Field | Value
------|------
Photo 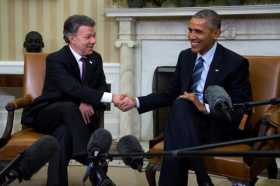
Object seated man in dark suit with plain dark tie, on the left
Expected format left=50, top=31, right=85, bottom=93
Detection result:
left=22, top=15, right=121, bottom=186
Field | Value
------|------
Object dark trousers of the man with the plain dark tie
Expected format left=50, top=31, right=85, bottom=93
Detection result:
left=33, top=102, right=95, bottom=186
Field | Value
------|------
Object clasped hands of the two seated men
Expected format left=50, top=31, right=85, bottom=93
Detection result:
left=112, top=94, right=136, bottom=112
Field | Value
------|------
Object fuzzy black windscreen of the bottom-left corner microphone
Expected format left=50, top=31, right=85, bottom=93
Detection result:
left=19, top=135, right=59, bottom=180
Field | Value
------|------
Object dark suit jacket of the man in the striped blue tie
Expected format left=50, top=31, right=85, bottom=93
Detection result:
left=138, top=44, right=251, bottom=139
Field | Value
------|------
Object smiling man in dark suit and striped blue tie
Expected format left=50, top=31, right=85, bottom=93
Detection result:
left=120, top=9, right=251, bottom=186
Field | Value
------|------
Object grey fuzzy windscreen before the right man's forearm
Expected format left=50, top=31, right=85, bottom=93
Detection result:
left=204, top=85, right=232, bottom=111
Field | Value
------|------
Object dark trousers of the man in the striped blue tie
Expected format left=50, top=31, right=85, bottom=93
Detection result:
left=159, top=99, right=211, bottom=186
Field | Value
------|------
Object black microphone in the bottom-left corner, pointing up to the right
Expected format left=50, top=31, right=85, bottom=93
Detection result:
left=0, top=135, right=59, bottom=186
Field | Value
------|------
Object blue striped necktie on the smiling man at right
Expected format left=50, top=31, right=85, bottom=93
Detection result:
left=191, top=57, right=204, bottom=93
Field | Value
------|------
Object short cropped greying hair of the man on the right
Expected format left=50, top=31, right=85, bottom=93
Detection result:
left=192, top=9, right=221, bottom=30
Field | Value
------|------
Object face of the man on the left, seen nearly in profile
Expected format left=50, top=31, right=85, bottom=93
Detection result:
left=69, top=26, right=96, bottom=56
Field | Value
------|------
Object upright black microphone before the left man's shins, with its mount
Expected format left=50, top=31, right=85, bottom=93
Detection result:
left=83, top=128, right=115, bottom=186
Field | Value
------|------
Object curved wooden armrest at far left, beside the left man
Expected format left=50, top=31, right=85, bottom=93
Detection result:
left=0, top=95, right=32, bottom=148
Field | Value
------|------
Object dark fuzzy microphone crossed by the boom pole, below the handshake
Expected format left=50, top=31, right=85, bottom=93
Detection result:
left=117, top=135, right=144, bottom=172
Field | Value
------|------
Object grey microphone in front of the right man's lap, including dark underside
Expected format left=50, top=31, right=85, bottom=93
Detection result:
left=204, top=85, right=232, bottom=122
